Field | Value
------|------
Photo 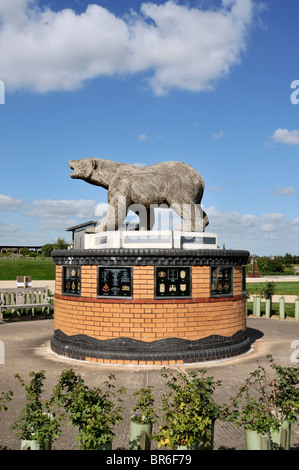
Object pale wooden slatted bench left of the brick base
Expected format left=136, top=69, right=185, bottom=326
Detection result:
left=0, top=287, right=53, bottom=319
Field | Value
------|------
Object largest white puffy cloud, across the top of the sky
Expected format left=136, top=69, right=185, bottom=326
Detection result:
left=0, top=0, right=254, bottom=95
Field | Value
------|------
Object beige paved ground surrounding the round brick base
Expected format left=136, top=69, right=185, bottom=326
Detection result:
left=0, top=317, right=299, bottom=450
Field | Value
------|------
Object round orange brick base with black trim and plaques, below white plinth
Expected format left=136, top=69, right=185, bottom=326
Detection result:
left=51, top=248, right=250, bottom=365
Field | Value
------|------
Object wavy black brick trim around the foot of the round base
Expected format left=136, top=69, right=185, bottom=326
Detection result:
left=51, top=330, right=251, bottom=363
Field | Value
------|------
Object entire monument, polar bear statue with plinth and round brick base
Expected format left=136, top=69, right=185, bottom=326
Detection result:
left=51, top=158, right=250, bottom=365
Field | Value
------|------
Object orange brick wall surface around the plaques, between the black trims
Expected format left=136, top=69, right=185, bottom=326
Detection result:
left=54, top=266, right=246, bottom=342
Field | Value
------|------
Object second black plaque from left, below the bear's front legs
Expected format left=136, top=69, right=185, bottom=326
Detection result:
left=98, top=266, right=132, bottom=297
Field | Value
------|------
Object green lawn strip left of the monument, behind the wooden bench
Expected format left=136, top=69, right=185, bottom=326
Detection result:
left=0, top=258, right=55, bottom=281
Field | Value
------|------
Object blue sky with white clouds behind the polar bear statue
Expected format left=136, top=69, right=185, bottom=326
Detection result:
left=0, top=0, right=299, bottom=256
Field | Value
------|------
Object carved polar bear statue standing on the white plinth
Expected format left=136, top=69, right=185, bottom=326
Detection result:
left=69, top=158, right=209, bottom=232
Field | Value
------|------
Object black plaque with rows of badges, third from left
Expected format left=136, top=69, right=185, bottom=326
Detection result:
left=155, top=266, right=191, bottom=298
